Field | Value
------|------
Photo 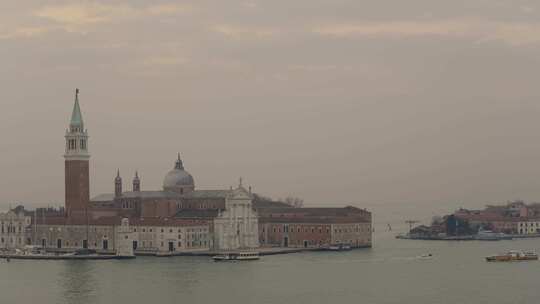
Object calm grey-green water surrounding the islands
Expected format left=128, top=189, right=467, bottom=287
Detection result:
left=0, top=203, right=540, bottom=304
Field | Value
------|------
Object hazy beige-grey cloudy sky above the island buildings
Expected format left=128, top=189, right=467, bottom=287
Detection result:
left=0, top=0, right=540, bottom=213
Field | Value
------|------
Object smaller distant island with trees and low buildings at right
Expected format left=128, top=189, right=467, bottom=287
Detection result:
left=397, top=200, right=540, bottom=240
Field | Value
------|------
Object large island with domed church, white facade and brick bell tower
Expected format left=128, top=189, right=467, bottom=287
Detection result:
left=0, top=90, right=372, bottom=255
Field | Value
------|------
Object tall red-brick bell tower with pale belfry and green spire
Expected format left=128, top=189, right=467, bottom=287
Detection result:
left=64, top=89, right=90, bottom=218
